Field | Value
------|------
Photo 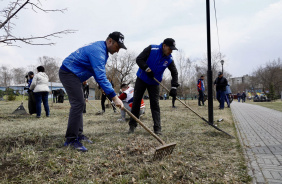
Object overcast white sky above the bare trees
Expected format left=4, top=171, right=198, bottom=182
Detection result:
left=0, top=0, right=282, bottom=77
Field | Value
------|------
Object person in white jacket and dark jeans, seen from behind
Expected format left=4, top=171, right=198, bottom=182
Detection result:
left=30, top=66, right=50, bottom=118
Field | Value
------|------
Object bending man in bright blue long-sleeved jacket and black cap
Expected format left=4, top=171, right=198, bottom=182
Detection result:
left=59, top=32, right=126, bottom=151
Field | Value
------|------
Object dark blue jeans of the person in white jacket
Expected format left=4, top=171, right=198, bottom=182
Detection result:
left=34, top=92, right=50, bottom=116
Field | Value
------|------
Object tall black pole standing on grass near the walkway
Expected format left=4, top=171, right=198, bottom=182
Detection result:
left=206, top=0, right=213, bottom=124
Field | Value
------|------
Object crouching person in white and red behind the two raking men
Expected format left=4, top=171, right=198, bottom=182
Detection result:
left=118, top=84, right=145, bottom=121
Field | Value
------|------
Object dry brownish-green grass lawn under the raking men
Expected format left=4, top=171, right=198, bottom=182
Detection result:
left=0, top=100, right=251, bottom=184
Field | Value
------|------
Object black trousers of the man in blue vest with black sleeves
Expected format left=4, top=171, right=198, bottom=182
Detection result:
left=129, top=77, right=161, bottom=131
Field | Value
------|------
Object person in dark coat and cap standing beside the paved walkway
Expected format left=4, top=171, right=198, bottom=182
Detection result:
left=214, top=72, right=228, bottom=110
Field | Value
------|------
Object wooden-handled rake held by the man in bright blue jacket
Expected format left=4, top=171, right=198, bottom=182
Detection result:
left=123, top=108, right=176, bottom=160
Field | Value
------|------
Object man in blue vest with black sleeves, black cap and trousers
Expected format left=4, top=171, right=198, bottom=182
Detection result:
left=128, top=38, right=179, bottom=135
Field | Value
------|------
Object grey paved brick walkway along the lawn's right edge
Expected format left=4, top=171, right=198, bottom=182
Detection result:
left=231, top=101, right=282, bottom=184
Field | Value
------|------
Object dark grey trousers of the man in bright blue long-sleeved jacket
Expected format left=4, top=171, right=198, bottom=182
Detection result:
left=59, top=69, right=85, bottom=141
